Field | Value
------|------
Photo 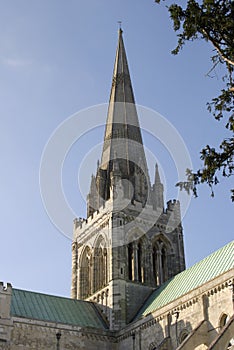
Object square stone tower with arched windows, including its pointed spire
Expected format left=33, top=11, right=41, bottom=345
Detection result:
left=71, top=29, right=185, bottom=330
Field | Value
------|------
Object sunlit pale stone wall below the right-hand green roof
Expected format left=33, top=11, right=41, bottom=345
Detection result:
left=115, top=271, right=233, bottom=350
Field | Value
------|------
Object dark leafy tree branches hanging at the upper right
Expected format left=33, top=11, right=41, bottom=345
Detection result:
left=155, top=0, right=234, bottom=201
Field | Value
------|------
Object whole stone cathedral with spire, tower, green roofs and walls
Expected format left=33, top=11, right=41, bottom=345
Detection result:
left=0, top=29, right=234, bottom=350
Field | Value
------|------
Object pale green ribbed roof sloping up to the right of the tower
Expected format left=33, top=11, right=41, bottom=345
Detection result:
left=136, top=241, right=234, bottom=319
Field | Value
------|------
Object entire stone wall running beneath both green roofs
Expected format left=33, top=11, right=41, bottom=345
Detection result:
left=0, top=270, right=234, bottom=350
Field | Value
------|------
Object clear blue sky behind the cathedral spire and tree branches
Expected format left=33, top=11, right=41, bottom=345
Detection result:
left=0, top=0, right=233, bottom=296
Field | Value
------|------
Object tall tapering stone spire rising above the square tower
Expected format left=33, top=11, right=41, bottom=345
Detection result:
left=94, top=28, right=150, bottom=203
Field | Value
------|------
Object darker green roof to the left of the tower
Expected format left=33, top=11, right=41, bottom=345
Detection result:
left=11, top=288, right=107, bottom=329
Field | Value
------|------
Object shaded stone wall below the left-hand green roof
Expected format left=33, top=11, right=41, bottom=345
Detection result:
left=0, top=318, right=116, bottom=350
